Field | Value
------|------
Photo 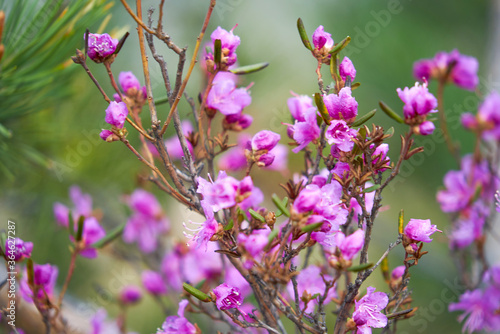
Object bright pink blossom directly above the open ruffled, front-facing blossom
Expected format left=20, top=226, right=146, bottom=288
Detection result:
left=323, top=87, right=358, bottom=122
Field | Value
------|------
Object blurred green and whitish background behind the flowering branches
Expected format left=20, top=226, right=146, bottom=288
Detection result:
left=0, top=0, right=492, bottom=333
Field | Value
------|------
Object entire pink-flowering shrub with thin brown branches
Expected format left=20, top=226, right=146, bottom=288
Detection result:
left=2, top=1, right=500, bottom=334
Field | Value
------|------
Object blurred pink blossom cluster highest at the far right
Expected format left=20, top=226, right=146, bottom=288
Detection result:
left=413, top=50, right=479, bottom=90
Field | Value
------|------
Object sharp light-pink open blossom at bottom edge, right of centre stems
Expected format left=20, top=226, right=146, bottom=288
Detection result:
left=352, top=286, right=389, bottom=334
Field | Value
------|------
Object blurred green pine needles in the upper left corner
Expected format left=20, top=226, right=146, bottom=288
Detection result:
left=0, top=0, right=110, bottom=179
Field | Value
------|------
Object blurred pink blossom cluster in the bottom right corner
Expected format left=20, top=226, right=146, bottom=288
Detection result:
left=448, top=289, right=500, bottom=334
